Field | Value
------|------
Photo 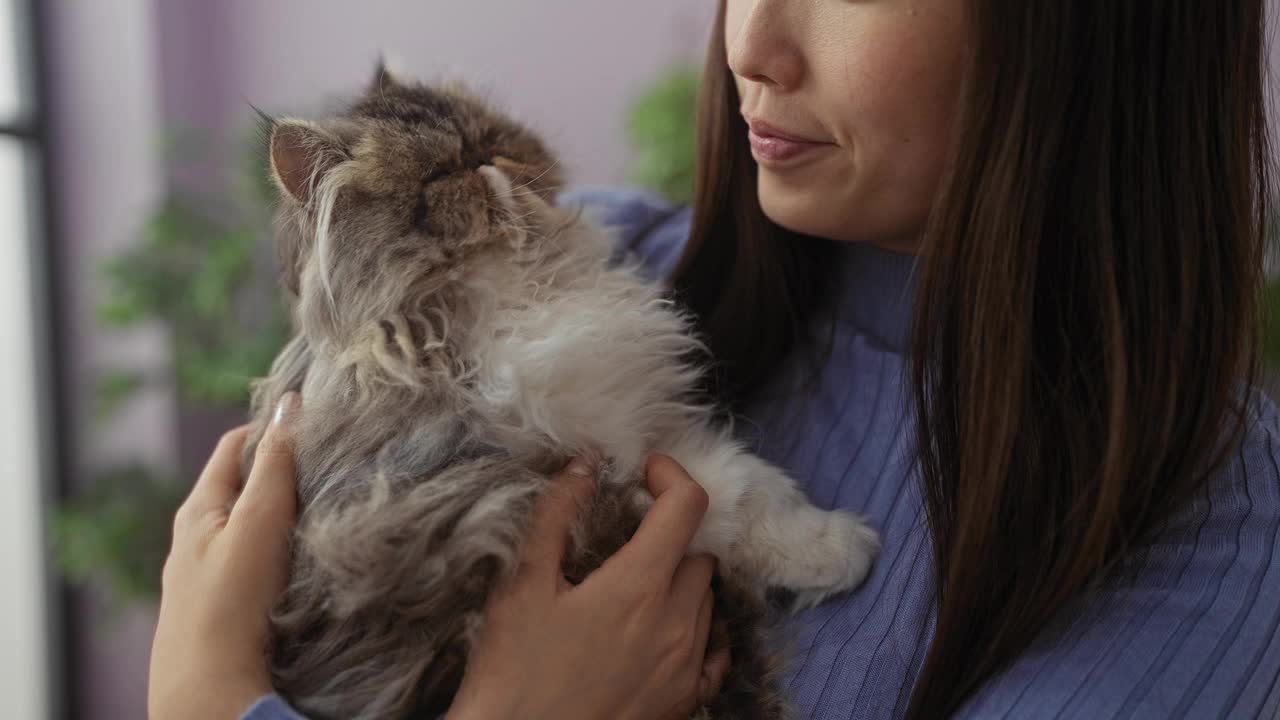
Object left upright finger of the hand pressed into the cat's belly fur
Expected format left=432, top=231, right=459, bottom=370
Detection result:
left=520, top=457, right=595, bottom=591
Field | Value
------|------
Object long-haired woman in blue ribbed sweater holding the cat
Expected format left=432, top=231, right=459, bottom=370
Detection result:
left=151, top=0, right=1280, bottom=719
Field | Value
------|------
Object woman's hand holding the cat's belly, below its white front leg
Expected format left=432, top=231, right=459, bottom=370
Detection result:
left=448, top=456, right=730, bottom=720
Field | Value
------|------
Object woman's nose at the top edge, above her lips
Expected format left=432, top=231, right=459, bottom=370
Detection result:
left=726, top=0, right=804, bottom=90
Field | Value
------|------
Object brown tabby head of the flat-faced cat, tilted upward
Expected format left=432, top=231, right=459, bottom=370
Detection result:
left=270, top=67, right=558, bottom=327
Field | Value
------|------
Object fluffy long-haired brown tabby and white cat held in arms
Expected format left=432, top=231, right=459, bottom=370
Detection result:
left=244, top=67, right=878, bottom=720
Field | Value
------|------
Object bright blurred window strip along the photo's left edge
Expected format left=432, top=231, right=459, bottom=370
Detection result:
left=0, top=0, right=63, bottom=719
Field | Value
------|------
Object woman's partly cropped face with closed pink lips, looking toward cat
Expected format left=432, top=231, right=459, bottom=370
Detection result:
left=724, top=0, right=963, bottom=252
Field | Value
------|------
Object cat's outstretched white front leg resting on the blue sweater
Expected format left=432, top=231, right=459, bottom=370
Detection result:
left=655, top=428, right=879, bottom=607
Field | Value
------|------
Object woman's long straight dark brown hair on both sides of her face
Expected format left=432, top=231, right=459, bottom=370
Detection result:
left=673, top=0, right=1271, bottom=719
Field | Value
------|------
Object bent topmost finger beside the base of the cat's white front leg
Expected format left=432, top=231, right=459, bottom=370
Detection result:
left=607, top=455, right=708, bottom=580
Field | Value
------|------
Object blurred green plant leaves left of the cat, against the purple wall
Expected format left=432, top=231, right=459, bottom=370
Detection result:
left=60, top=131, right=291, bottom=605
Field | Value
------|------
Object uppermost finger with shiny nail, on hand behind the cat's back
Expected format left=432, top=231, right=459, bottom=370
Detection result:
left=227, top=392, right=300, bottom=536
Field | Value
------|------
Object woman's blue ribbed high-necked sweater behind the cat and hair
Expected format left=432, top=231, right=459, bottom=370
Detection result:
left=244, top=191, right=1280, bottom=720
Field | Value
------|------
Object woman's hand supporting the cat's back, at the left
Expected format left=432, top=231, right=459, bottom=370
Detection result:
left=147, top=393, right=298, bottom=720
